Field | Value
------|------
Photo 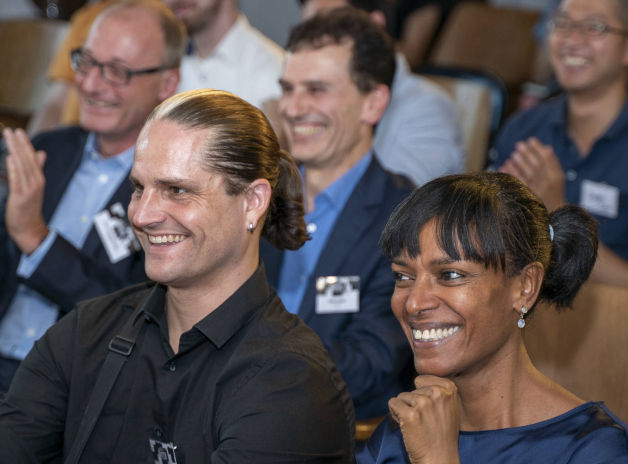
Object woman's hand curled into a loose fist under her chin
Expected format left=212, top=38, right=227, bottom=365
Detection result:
left=388, top=375, right=460, bottom=464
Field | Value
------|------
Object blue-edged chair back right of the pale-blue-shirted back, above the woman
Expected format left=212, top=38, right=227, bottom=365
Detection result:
left=416, top=65, right=507, bottom=172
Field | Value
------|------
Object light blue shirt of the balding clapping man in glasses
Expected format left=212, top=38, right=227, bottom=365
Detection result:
left=0, top=133, right=134, bottom=360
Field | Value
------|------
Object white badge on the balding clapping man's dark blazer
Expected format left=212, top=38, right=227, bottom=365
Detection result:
left=94, top=203, right=140, bottom=264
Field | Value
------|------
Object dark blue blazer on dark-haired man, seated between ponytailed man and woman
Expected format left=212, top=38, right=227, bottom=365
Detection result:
left=260, top=157, right=413, bottom=419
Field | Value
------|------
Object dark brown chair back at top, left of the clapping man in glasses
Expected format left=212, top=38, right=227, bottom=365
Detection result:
left=428, top=2, right=540, bottom=115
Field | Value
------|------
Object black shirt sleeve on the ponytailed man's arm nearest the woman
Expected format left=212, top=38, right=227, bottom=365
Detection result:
left=211, top=346, right=355, bottom=464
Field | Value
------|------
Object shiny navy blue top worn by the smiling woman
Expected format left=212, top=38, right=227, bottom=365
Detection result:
left=356, top=403, right=628, bottom=464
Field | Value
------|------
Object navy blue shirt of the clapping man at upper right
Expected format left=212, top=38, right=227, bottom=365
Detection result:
left=493, top=95, right=628, bottom=259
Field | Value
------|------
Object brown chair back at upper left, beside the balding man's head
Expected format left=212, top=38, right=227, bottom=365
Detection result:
left=0, top=19, right=68, bottom=127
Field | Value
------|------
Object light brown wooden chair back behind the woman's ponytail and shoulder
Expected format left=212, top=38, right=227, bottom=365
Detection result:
left=524, top=283, right=628, bottom=421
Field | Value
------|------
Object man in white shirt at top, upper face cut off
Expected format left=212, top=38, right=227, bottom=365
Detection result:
left=164, top=0, right=283, bottom=108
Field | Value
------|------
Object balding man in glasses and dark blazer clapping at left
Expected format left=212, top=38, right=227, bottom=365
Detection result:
left=0, top=0, right=185, bottom=391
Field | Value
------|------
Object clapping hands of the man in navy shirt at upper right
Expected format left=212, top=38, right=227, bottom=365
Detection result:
left=499, top=137, right=567, bottom=211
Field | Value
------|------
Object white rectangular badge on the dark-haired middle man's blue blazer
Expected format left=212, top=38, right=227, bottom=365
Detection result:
left=316, top=276, right=360, bottom=314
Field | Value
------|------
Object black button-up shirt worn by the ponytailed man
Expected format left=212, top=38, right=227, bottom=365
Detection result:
left=0, top=267, right=354, bottom=464
